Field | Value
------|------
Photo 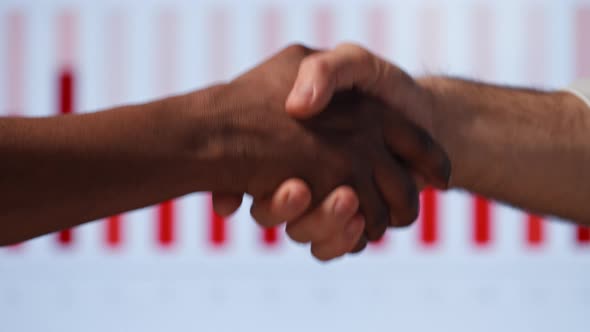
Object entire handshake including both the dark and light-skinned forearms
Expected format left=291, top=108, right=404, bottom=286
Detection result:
left=5, top=44, right=590, bottom=252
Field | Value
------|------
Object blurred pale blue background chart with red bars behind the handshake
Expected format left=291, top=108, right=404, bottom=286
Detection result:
left=0, top=0, right=590, bottom=332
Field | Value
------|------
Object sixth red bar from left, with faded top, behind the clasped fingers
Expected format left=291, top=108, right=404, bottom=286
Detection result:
left=262, top=8, right=282, bottom=247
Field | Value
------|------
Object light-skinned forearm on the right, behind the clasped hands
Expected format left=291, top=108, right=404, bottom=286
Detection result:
left=419, top=77, right=590, bottom=224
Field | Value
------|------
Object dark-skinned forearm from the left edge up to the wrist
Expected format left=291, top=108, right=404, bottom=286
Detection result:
left=0, top=83, right=245, bottom=244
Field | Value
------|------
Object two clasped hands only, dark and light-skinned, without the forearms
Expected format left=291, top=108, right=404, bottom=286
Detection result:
left=185, top=44, right=451, bottom=260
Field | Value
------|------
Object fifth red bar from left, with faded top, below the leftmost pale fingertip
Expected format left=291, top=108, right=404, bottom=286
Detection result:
left=208, top=8, right=230, bottom=248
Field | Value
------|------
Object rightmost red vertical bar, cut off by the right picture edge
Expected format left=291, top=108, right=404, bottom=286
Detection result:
left=575, top=5, right=590, bottom=245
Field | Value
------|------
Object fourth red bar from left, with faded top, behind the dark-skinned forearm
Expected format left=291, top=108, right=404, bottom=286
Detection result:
left=156, top=10, right=178, bottom=247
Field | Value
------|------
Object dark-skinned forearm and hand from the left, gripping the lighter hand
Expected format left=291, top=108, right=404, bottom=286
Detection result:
left=0, top=46, right=448, bottom=248
